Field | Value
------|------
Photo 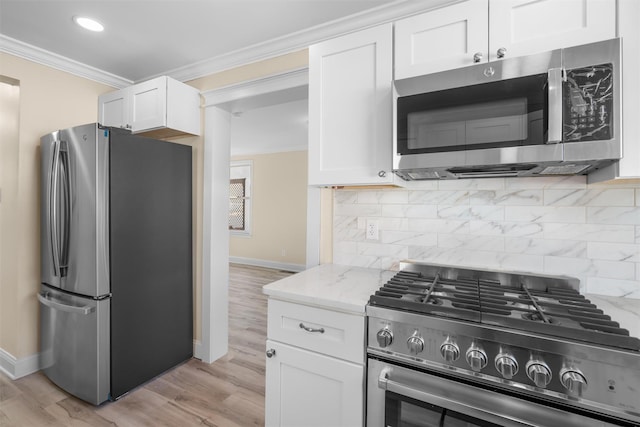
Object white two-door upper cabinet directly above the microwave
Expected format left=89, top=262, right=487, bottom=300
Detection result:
left=395, top=0, right=616, bottom=80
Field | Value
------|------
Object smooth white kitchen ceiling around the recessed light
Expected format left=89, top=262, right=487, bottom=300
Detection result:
left=0, top=0, right=406, bottom=82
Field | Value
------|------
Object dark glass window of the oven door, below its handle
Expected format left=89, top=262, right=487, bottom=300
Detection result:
left=384, top=392, right=500, bottom=427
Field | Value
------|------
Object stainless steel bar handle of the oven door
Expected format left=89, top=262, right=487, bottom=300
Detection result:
left=378, top=367, right=521, bottom=425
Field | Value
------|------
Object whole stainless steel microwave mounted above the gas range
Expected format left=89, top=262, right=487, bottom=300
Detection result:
left=393, top=39, right=622, bottom=180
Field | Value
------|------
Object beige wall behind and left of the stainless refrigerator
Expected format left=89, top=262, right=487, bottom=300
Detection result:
left=0, top=53, right=112, bottom=358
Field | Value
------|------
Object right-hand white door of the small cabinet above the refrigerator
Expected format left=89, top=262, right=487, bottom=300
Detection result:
left=131, top=77, right=167, bottom=133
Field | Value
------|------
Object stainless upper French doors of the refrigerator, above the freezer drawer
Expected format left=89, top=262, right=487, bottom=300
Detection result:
left=40, top=124, right=110, bottom=297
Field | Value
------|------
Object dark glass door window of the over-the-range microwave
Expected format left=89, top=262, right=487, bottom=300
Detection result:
left=397, top=73, right=549, bottom=154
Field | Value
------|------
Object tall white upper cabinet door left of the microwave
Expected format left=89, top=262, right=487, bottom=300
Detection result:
left=309, top=24, right=393, bottom=185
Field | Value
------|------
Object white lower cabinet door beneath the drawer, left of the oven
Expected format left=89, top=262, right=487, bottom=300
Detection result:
left=265, top=340, right=364, bottom=427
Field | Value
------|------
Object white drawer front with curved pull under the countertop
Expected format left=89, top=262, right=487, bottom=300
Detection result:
left=267, top=299, right=365, bottom=364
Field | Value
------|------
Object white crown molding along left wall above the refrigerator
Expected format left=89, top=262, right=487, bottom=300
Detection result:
left=0, top=34, right=133, bottom=88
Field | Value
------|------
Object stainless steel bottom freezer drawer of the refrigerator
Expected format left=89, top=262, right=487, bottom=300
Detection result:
left=38, top=286, right=111, bottom=405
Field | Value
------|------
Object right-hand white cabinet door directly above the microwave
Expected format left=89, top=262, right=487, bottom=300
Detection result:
left=489, top=0, right=616, bottom=61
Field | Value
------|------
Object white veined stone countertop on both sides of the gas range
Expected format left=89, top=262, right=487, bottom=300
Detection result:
left=262, top=264, right=640, bottom=337
